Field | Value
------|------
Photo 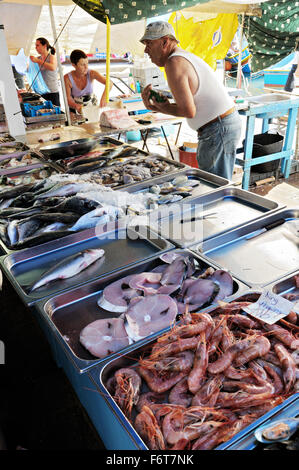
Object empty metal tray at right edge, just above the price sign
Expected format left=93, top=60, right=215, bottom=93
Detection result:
left=190, top=209, right=299, bottom=288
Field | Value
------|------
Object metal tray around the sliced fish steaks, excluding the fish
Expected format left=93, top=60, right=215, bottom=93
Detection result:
left=35, top=250, right=245, bottom=372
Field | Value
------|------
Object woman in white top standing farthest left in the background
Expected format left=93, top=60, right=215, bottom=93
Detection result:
left=30, top=38, right=60, bottom=106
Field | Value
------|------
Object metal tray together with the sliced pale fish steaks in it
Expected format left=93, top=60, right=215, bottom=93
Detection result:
left=34, top=246, right=245, bottom=375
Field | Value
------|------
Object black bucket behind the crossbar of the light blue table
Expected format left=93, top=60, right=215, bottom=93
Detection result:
left=243, top=132, right=284, bottom=173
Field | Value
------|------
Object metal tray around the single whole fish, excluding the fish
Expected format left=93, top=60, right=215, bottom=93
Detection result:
left=0, top=224, right=173, bottom=306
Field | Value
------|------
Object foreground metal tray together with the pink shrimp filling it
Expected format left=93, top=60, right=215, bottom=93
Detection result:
left=74, top=291, right=298, bottom=450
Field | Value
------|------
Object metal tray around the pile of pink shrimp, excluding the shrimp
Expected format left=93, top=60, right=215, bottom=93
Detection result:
left=87, top=290, right=299, bottom=450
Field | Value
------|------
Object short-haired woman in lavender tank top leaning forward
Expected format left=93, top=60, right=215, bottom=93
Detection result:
left=64, top=49, right=113, bottom=113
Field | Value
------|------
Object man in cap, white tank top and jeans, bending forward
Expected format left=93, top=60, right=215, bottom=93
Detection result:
left=140, top=21, right=241, bottom=179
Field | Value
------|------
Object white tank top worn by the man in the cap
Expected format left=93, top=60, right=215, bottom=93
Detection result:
left=169, top=49, right=235, bottom=130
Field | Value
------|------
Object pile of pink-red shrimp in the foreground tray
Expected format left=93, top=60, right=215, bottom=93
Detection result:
left=107, top=301, right=299, bottom=450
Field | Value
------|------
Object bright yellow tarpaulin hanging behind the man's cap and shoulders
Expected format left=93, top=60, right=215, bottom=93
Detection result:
left=168, top=11, right=238, bottom=70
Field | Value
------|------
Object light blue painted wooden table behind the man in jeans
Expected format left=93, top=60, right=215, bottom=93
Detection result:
left=236, top=94, right=299, bottom=189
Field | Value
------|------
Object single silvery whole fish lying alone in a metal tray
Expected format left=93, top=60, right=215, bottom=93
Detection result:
left=30, top=248, right=105, bottom=292
